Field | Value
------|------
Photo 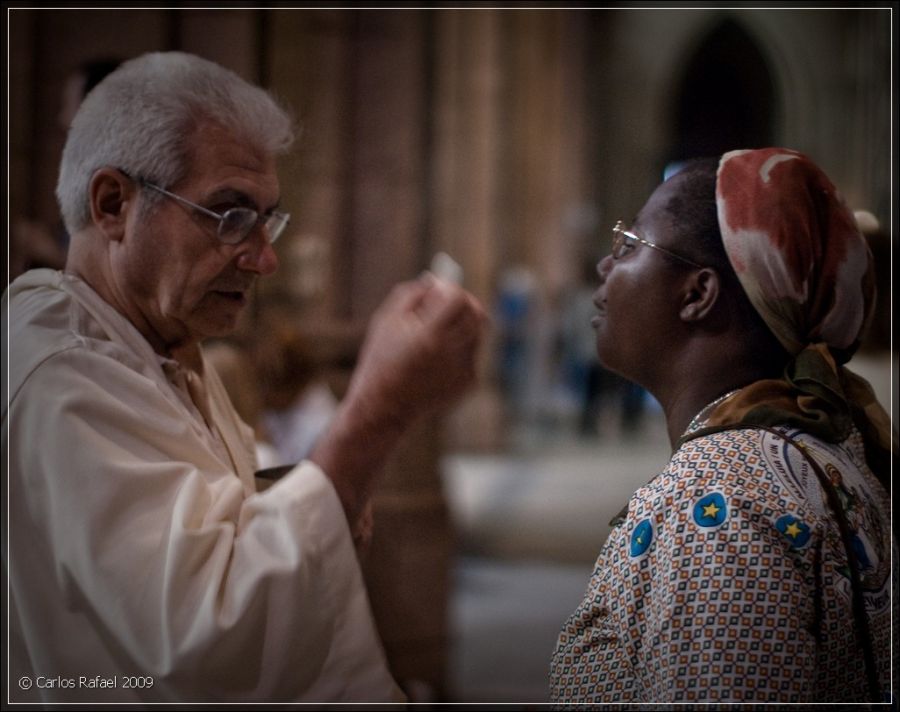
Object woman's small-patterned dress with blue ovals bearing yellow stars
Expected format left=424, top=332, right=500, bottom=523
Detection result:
left=550, top=414, right=896, bottom=704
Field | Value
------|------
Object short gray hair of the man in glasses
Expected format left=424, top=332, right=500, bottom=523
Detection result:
left=56, top=52, right=294, bottom=233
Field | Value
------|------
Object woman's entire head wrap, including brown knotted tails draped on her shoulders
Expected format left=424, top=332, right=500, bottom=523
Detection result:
left=693, top=148, right=893, bottom=482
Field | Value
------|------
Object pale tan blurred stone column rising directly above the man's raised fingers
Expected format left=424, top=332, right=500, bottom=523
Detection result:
left=430, top=10, right=505, bottom=450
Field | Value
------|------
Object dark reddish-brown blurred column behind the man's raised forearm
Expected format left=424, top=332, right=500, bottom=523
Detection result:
left=341, top=11, right=453, bottom=701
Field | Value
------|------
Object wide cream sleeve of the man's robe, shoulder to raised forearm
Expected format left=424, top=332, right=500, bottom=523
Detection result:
left=4, top=348, right=396, bottom=701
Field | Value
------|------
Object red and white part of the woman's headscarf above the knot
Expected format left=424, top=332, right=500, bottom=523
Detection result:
left=716, top=148, right=875, bottom=362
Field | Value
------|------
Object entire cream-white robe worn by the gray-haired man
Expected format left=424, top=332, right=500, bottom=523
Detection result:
left=2, top=270, right=402, bottom=702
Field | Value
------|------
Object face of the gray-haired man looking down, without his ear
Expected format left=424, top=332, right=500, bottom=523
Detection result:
left=110, top=123, right=279, bottom=350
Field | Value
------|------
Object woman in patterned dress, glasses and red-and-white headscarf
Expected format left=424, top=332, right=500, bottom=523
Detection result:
left=551, top=148, right=896, bottom=703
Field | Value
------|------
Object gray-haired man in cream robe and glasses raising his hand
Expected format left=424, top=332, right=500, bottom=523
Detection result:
left=3, top=53, right=483, bottom=702
